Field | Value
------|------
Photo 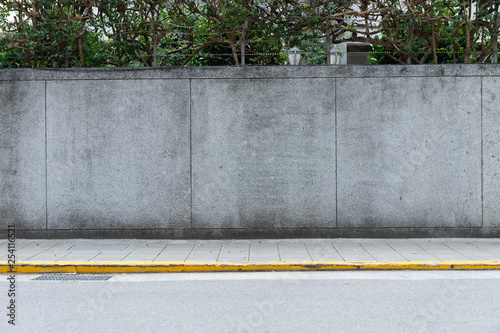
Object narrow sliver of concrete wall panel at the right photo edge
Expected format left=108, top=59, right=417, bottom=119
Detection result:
left=482, top=77, right=500, bottom=227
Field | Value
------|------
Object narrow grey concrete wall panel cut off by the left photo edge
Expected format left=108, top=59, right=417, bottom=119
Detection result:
left=0, top=81, right=46, bottom=229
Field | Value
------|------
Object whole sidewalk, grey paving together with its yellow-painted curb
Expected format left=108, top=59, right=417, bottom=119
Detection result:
left=0, top=238, right=500, bottom=274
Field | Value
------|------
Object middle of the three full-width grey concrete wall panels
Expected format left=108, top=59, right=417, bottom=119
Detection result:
left=191, top=78, right=335, bottom=229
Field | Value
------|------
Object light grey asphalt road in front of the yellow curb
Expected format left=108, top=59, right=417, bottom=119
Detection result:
left=0, top=271, right=500, bottom=332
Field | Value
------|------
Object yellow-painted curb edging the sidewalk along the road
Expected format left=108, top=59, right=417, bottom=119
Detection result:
left=0, top=260, right=500, bottom=274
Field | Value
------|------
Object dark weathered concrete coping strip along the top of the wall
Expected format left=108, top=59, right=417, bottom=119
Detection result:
left=0, top=64, right=500, bottom=81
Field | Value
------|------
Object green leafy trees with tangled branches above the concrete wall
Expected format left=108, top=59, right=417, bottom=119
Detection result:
left=0, top=0, right=500, bottom=67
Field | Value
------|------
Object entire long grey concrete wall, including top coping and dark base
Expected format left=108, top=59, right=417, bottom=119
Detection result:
left=0, top=65, right=500, bottom=238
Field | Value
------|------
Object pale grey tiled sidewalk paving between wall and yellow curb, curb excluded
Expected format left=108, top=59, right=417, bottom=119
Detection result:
left=5, top=239, right=500, bottom=262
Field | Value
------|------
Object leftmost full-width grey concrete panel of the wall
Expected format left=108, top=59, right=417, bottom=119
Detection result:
left=47, top=80, right=191, bottom=229
